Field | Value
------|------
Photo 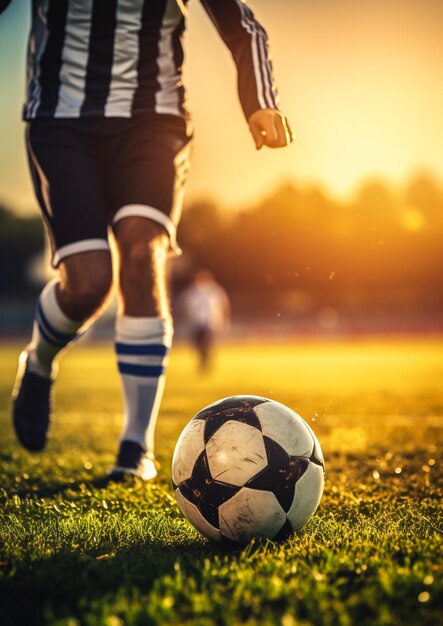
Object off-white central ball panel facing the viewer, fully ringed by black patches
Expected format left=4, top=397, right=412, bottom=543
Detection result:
left=206, top=420, right=268, bottom=487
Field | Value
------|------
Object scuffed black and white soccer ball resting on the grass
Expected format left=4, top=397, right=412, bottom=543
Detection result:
left=172, top=396, right=324, bottom=543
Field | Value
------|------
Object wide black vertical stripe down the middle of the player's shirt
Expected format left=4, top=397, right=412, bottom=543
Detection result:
left=82, top=0, right=117, bottom=115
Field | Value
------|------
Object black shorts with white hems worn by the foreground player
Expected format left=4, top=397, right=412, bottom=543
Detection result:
left=26, top=114, right=192, bottom=267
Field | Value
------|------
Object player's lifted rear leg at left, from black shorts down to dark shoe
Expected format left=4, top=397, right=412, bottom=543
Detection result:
left=13, top=120, right=112, bottom=451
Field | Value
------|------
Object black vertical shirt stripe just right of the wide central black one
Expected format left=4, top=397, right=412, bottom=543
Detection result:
left=132, top=0, right=167, bottom=111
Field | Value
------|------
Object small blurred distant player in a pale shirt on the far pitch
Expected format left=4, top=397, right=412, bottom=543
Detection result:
left=179, top=270, right=230, bottom=370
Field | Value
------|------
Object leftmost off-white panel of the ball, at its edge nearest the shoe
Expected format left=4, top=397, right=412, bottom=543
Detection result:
left=172, top=420, right=206, bottom=485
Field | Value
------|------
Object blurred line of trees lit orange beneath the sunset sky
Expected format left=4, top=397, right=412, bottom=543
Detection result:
left=0, top=174, right=443, bottom=312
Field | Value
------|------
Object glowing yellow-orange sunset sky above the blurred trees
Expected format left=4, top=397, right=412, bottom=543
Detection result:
left=0, top=0, right=443, bottom=211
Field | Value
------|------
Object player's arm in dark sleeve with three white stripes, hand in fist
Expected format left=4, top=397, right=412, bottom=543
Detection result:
left=201, top=0, right=292, bottom=150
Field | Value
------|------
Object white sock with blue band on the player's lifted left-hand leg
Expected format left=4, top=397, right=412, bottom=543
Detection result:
left=25, top=280, right=88, bottom=378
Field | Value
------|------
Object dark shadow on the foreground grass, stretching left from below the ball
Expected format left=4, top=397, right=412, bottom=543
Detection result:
left=0, top=542, right=241, bottom=626
